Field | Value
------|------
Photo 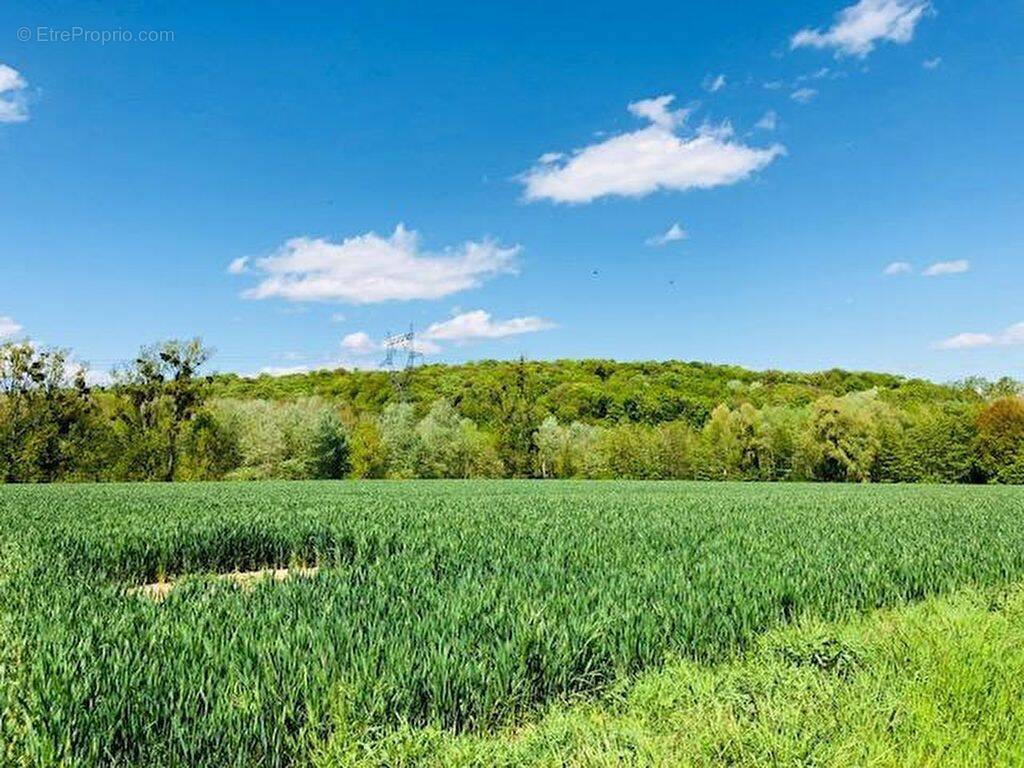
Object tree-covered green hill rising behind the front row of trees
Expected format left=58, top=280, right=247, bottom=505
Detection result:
left=214, top=359, right=974, bottom=423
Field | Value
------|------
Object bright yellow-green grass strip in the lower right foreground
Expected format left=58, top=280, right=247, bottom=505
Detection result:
left=317, top=588, right=1024, bottom=768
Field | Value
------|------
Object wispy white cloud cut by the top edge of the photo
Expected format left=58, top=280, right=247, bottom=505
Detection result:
left=790, top=0, right=932, bottom=58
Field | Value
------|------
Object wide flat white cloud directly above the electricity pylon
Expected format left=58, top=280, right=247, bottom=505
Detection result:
left=235, top=224, right=519, bottom=304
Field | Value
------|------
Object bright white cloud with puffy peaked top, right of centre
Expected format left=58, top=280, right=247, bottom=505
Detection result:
left=521, top=96, right=785, bottom=203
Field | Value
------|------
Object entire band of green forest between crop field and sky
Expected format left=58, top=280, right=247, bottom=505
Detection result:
left=0, top=339, right=1024, bottom=483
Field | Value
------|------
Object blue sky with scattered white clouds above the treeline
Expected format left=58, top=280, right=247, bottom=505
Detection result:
left=0, top=0, right=1024, bottom=380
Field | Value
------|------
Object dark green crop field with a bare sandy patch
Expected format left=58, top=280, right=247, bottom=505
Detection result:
left=0, top=481, right=1024, bottom=766
